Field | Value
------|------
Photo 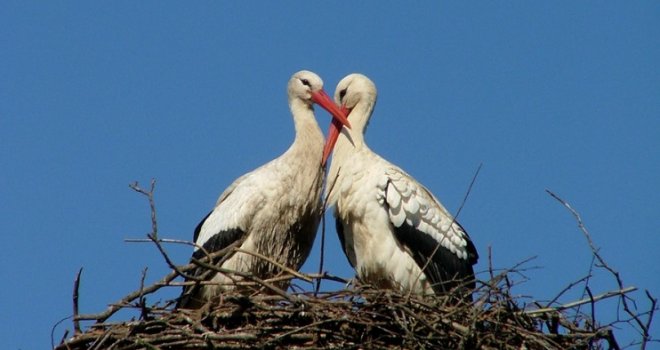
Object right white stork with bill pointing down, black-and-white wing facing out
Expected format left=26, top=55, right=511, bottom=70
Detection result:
left=323, top=74, right=478, bottom=299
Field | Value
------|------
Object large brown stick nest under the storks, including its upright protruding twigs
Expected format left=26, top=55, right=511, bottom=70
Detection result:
left=54, top=182, right=657, bottom=350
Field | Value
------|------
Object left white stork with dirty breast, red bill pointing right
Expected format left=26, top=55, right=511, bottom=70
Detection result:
left=177, top=71, right=348, bottom=309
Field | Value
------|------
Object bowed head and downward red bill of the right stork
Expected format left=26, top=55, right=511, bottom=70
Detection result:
left=323, top=73, right=378, bottom=163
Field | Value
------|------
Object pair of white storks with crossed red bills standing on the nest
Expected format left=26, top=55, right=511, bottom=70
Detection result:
left=178, top=71, right=478, bottom=308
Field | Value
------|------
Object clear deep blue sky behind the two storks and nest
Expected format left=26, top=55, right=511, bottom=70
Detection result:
left=0, top=1, right=660, bottom=349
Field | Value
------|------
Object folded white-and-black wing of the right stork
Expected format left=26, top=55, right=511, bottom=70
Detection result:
left=378, top=167, right=478, bottom=293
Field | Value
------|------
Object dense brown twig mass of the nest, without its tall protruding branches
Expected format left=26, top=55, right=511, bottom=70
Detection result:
left=57, top=268, right=636, bottom=350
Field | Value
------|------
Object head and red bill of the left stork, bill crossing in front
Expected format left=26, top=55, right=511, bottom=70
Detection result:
left=288, top=70, right=351, bottom=165
